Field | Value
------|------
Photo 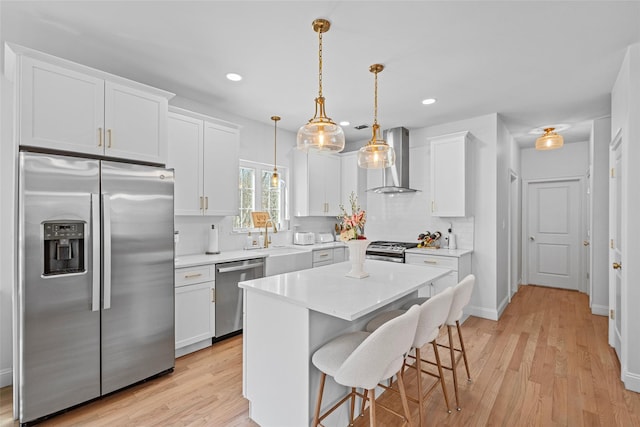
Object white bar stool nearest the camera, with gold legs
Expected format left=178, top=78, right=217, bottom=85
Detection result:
left=311, top=306, right=420, bottom=427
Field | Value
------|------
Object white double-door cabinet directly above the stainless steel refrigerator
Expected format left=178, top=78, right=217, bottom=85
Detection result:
left=8, top=45, right=173, bottom=164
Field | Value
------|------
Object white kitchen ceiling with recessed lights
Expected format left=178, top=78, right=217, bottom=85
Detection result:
left=0, top=0, right=640, bottom=147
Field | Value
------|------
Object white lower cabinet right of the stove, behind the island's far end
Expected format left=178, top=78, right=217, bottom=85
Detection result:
left=405, top=252, right=471, bottom=297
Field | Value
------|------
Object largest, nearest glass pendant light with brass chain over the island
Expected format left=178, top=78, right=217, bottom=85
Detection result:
left=297, top=19, right=344, bottom=153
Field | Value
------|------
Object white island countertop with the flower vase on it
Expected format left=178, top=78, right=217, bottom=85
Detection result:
left=238, top=260, right=451, bottom=321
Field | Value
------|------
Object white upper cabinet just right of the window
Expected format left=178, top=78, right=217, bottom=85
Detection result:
left=293, top=150, right=341, bottom=216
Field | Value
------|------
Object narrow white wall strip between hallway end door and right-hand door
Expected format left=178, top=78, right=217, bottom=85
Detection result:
left=589, top=117, right=611, bottom=316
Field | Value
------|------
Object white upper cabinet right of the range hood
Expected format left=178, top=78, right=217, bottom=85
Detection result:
left=430, top=131, right=472, bottom=217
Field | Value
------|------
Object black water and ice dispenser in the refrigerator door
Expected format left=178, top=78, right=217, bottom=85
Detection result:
left=42, top=221, right=85, bottom=276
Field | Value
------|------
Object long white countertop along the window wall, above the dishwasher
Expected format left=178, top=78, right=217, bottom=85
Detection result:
left=175, top=242, right=347, bottom=268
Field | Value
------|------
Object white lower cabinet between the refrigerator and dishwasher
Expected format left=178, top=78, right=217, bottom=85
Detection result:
left=175, top=265, right=216, bottom=357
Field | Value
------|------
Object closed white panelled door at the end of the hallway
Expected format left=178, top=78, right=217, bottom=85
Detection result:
left=527, top=179, right=582, bottom=290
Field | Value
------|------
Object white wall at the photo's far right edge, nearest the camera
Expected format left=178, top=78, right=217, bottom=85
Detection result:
left=611, top=44, right=640, bottom=392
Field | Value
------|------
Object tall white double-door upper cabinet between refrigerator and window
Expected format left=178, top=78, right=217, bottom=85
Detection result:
left=167, top=107, right=239, bottom=216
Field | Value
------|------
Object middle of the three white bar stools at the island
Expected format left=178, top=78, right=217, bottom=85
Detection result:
left=366, top=288, right=453, bottom=425
